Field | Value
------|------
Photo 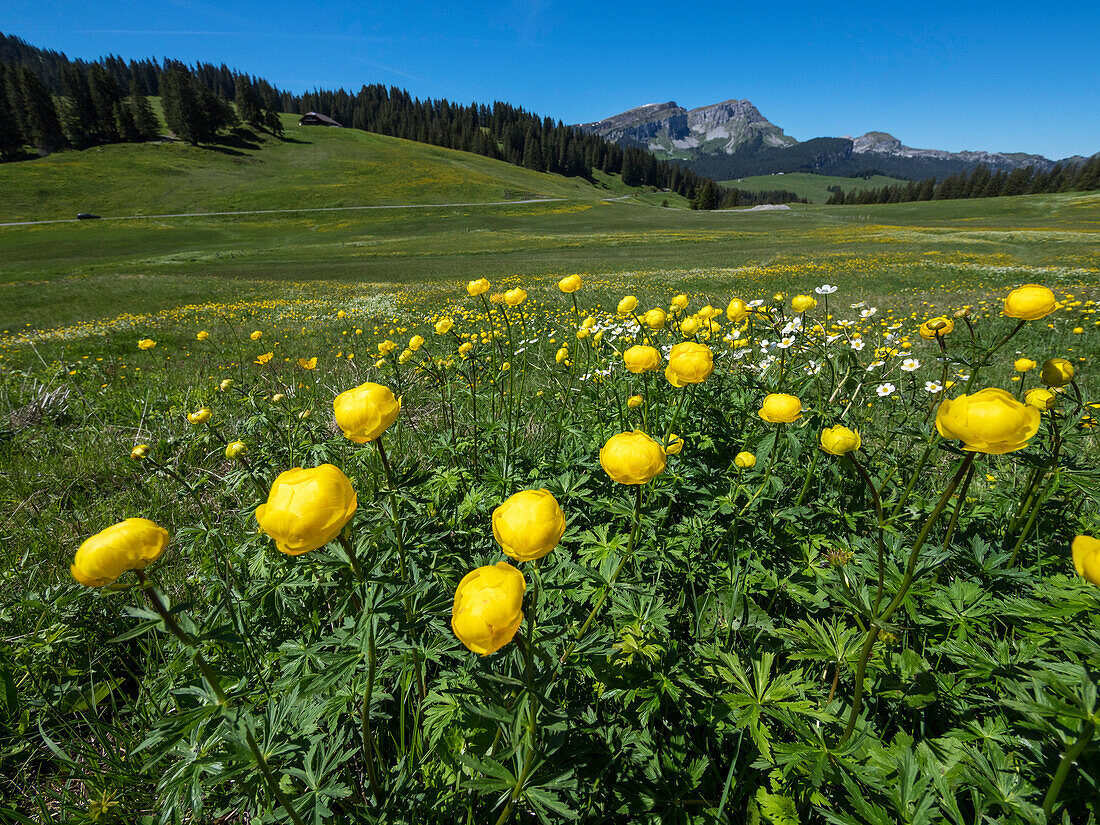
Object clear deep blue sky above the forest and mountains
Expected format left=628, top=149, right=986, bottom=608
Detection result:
left=0, top=0, right=1100, bottom=157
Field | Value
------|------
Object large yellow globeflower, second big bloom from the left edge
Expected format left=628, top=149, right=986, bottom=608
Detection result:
left=256, top=464, right=359, bottom=556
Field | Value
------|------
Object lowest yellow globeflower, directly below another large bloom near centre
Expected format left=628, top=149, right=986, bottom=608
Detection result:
left=451, top=561, right=527, bottom=656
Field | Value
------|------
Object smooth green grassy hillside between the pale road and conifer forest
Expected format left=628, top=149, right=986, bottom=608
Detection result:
left=0, top=114, right=682, bottom=222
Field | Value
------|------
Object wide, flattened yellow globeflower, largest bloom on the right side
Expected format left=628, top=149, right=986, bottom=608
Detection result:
left=936, top=388, right=1040, bottom=455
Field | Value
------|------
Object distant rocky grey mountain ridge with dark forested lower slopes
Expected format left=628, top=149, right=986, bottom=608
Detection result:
left=576, top=99, right=1086, bottom=180
